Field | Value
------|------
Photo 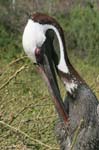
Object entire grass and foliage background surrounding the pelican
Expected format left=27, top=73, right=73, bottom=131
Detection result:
left=0, top=0, right=99, bottom=150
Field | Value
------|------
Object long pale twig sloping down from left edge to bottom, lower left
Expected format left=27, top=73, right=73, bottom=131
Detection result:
left=0, top=121, right=59, bottom=150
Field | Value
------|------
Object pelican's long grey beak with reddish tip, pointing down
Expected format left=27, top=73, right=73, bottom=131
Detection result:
left=36, top=54, right=68, bottom=123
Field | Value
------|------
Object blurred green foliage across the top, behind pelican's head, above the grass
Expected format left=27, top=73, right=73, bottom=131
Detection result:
left=0, top=0, right=99, bottom=65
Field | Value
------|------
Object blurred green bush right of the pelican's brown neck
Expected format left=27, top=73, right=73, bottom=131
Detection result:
left=65, top=5, right=99, bottom=65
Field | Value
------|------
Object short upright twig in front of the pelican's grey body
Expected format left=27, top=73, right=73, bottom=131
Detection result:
left=70, top=119, right=84, bottom=150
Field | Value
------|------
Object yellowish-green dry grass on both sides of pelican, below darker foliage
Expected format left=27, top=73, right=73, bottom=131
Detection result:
left=0, top=54, right=99, bottom=150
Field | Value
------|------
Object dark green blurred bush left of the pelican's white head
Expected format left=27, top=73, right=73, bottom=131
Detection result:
left=0, top=25, right=22, bottom=63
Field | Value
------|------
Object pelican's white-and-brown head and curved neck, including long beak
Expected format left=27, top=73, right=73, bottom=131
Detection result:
left=22, top=13, right=82, bottom=122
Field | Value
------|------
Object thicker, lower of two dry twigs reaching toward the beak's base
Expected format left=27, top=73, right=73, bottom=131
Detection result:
left=0, top=65, right=27, bottom=90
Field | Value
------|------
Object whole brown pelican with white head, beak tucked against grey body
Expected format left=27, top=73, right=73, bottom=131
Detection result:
left=22, top=13, right=99, bottom=150
